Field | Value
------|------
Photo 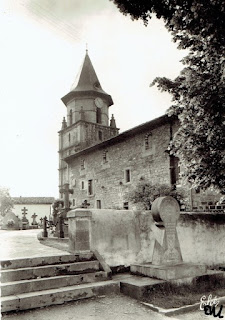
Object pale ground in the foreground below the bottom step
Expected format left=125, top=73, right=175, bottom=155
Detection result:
left=2, top=295, right=181, bottom=320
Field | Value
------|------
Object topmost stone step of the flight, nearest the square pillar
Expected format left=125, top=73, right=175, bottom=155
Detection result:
left=1, top=252, right=95, bottom=270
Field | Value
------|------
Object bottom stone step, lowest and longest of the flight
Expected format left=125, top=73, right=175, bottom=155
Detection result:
left=1, top=280, right=120, bottom=312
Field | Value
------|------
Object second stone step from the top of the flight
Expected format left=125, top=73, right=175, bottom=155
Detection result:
left=1, top=260, right=99, bottom=283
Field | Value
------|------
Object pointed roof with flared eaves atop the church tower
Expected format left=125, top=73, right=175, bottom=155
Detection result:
left=62, top=50, right=113, bottom=106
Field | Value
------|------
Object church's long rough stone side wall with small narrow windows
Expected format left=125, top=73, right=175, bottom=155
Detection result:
left=69, top=124, right=170, bottom=209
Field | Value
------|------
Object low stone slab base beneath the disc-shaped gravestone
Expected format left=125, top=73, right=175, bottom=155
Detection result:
left=130, top=263, right=207, bottom=280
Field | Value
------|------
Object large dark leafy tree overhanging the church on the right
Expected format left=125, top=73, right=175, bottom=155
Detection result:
left=113, top=0, right=225, bottom=194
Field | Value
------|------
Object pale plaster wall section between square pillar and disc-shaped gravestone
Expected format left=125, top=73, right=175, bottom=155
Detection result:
left=91, top=209, right=154, bottom=266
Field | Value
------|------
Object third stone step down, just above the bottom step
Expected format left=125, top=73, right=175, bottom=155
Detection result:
left=0, top=271, right=108, bottom=297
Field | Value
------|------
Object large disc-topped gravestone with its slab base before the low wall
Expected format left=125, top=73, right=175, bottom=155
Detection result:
left=130, top=196, right=207, bottom=280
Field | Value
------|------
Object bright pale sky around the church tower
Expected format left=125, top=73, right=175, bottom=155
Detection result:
left=0, top=0, right=186, bottom=197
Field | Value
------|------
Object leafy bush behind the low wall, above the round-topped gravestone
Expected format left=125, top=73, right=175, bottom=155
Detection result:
left=128, top=181, right=185, bottom=210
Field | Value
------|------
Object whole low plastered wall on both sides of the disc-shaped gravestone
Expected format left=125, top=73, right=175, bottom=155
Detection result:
left=69, top=209, right=225, bottom=267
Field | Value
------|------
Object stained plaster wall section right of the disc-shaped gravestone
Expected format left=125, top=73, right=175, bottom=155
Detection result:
left=177, top=212, right=225, bottom=266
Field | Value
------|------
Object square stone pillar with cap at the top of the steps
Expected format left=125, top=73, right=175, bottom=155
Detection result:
left=67, top=209, right=92, bottom=253
